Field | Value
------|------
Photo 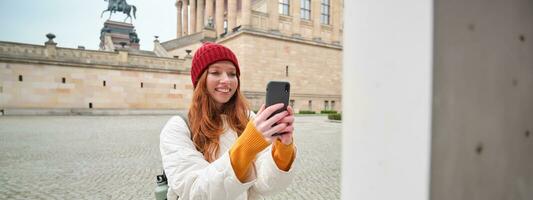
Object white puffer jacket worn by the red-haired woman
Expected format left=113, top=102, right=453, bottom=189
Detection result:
left=160, top=113, right=298, bottom=200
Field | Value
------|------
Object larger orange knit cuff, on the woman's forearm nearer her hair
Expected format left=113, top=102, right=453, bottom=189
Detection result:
left=230, top=121, right=269, bottom=182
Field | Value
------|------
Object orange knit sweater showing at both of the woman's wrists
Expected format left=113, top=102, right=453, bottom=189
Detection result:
left=230, top=121, right=294, bottom=182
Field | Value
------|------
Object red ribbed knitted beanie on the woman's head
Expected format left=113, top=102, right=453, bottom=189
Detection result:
left=191, top=42, right=240, bottom=88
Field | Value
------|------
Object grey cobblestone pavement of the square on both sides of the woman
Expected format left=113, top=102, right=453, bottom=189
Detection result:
left=0, top=116, right=341, bottom=199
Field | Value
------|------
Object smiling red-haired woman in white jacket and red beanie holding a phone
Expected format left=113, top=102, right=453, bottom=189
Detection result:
left=160, top=43, right=296, bottom=200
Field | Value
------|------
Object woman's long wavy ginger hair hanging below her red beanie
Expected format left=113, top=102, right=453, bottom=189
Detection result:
left=188, top=70, right=249, bottom=162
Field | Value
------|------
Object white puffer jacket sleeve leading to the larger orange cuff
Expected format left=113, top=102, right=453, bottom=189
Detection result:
left=160, top=116, right=255, bottom=200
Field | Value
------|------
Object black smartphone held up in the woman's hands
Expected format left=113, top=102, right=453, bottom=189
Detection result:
left=265, top=81, right=291, bottom=136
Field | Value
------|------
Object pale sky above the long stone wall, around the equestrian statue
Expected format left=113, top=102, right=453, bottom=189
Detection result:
left=0, top=0, right=176, bottom=50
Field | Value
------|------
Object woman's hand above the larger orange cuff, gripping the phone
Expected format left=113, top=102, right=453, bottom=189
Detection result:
left=254, top=103, right=292, bottom=143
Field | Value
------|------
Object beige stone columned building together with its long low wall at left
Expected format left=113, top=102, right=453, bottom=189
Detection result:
left=0, top=0, right=343, bottom=115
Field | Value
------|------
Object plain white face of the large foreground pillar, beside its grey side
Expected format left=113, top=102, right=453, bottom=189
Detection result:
left=341, top=0, right=433, bottom=200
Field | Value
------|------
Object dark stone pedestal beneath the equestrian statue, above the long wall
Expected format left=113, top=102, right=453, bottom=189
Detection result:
left=100, top=20, right=140, bottom=50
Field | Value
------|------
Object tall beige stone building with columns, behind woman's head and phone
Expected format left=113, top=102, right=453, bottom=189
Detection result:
left=162, top=0, right=343, bottom=112
